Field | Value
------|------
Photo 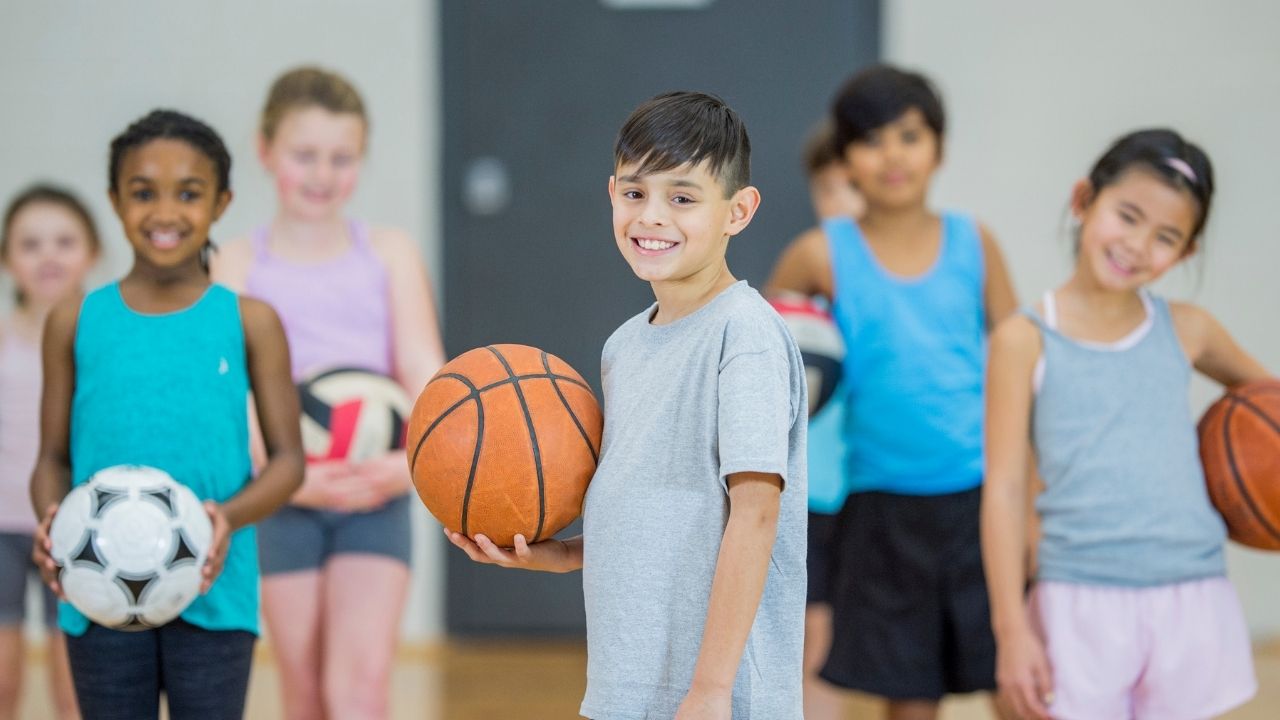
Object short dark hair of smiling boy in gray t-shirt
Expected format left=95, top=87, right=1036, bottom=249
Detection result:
left=613, top=92, right=751, bottom=197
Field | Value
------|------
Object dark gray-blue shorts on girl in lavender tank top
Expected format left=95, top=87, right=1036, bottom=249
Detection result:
left=257, top=495, right=412, bottom=575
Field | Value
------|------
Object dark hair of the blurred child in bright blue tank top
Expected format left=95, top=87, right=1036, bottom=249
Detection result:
left=831, top=65, right=947, bottom=152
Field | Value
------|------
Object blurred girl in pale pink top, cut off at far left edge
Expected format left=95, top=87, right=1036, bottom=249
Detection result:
left=0, top=184, right=100, bottom=717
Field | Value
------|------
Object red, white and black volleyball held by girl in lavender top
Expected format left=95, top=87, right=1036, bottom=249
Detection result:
left=298, top=368, right=410, bottom=462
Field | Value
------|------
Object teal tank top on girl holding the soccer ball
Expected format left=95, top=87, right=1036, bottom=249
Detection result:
left=59, top=283, right=257, bottom=635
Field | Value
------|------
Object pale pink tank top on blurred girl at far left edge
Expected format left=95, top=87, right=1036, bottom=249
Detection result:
left=0, top=334, right=42, bottom=533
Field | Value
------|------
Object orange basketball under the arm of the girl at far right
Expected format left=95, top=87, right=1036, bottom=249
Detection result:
left=1199, top=379, right=1280, bottom=550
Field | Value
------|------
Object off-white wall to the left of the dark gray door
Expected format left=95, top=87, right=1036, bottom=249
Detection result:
left=0, top=0, right=443, bottom=638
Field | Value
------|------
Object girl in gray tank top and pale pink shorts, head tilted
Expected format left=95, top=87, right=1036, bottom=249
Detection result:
left=982, top=129, right=1267, bottom=719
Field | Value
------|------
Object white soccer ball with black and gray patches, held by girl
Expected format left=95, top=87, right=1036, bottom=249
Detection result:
left=49, top=465, right=214, bottom=630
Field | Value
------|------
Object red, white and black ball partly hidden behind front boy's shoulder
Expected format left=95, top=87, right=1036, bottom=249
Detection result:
left=769, top=295, right=845, bottom=418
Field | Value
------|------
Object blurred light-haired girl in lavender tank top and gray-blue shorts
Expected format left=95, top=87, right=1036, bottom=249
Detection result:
left=212, top=67, right=444, bottom=717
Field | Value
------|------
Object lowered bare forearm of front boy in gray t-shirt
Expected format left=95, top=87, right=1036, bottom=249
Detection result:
left=692, top=503, right=778, bottom=691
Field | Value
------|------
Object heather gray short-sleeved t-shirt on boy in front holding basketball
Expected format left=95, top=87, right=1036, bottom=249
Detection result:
left=581, top=282, right=808, bottom=720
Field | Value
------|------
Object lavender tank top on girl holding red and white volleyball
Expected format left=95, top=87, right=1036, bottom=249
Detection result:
left=246, top=220, right=392, bottom=380
